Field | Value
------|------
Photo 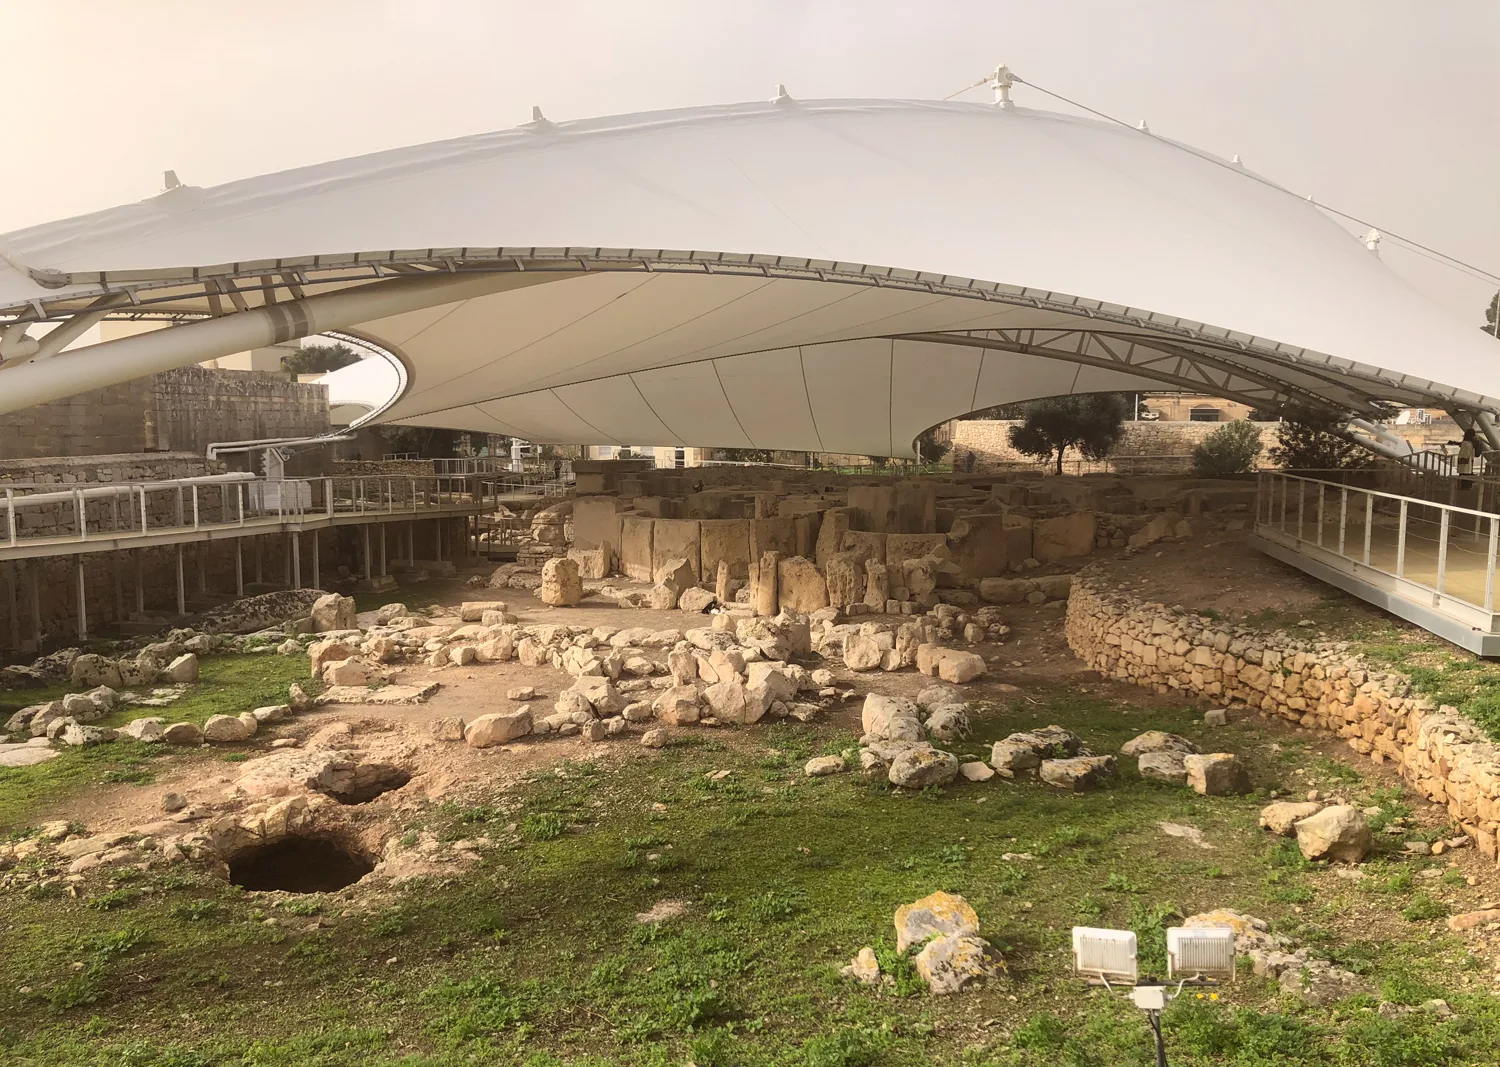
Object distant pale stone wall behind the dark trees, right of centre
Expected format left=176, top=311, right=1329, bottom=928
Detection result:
left=953, top=419, right=1281, bottom=474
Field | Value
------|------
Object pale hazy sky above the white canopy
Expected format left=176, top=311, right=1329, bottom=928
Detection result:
left=0, top=0, right=1500, bottom=326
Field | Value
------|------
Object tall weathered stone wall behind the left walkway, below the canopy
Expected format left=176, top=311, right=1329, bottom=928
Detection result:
left=0, top=366, right=329, bottom=459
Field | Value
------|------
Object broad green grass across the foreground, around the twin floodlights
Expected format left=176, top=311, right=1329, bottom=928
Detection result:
left=0, top=693, right=1500, bottom=1067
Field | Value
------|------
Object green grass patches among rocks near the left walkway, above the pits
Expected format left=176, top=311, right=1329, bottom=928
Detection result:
left=0, top=654, right=317, bottom=836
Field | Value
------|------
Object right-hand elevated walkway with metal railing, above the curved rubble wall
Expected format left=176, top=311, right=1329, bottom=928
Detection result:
left=1251, top=471, right=1500, bottom=656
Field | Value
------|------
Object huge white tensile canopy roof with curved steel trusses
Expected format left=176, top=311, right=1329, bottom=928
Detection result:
left=0, top=98, right=1500, bottom=456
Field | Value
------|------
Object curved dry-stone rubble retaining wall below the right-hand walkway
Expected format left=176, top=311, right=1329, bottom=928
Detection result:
left=1065, top=569, right=1500, bottom=858
